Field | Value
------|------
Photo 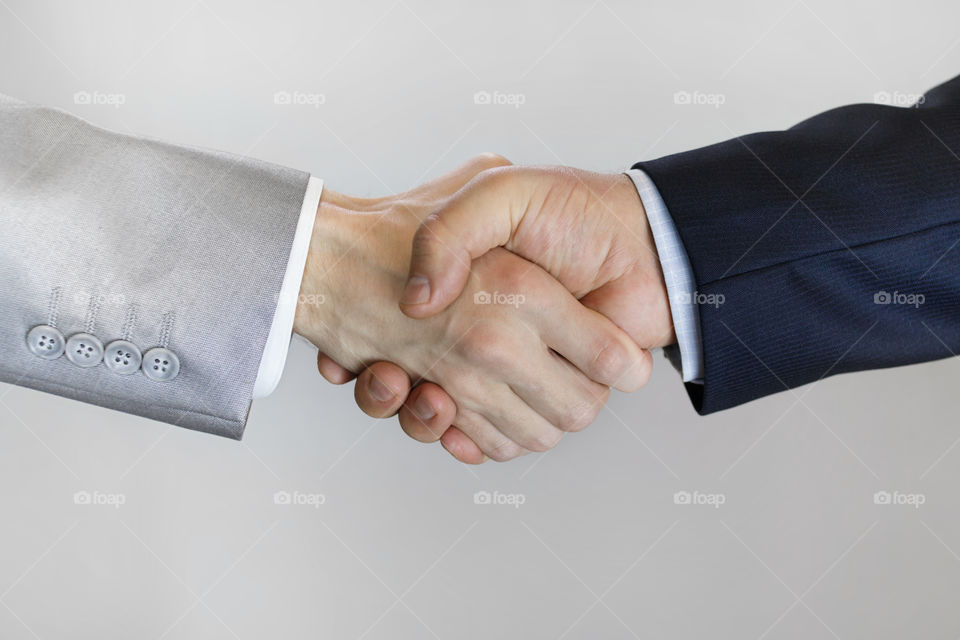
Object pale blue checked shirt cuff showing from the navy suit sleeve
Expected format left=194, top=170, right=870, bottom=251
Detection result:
left=627, top=169, right=703, bottom=383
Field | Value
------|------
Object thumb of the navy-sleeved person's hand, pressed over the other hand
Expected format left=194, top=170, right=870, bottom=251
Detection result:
left=400, top=167, right=526, bottom=318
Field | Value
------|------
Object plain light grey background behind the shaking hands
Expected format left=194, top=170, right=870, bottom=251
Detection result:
left=0, top=0, right=960, bottom=640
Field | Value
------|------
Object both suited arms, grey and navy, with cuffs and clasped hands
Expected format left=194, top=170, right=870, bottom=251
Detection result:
left=0, top=78, right=960, bottom=450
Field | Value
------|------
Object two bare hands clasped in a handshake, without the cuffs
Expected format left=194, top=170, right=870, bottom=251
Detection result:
left=294, top=154, right=676, bottom=464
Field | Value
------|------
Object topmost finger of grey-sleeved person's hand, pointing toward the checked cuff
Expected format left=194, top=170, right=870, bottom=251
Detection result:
left=532, top=282, right=653, bottom=392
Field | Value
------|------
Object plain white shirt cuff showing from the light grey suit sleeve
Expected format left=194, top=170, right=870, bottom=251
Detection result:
left=253, top=176, right=323, bottom=399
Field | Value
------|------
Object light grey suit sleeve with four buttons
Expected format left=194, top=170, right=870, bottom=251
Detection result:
left=0, top=96, right=309, bottom=439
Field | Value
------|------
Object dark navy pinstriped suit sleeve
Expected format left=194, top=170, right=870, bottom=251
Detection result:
left=635, top=77, right=960, bottom=414
